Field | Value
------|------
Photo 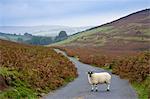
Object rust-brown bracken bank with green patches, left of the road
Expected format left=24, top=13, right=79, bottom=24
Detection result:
left=0, top=40, right=77, bottom=99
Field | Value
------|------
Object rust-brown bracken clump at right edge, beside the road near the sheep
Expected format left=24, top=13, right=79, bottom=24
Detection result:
left=113, top=52, right=150, bottom=82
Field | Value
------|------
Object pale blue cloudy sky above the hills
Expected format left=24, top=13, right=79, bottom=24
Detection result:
left=0, top=0, right=150, bottom=26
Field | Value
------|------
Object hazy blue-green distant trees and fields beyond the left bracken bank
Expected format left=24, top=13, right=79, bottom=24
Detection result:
left=0, top=31, right=68, bottom=45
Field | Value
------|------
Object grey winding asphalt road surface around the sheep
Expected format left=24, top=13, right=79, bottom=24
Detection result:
left=44, top=50, right=137, bottom=99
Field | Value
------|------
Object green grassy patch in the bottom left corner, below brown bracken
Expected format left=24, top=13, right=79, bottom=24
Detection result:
left=0, top=67, right=36, bottom=99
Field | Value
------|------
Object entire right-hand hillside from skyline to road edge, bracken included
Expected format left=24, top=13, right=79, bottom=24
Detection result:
left=50, top=9, right=150, bottom=99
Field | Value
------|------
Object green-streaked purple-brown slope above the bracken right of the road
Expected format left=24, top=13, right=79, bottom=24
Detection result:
left=55, top=9, right=150, bottom=55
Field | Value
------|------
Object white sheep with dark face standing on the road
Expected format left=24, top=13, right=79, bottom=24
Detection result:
left=88, top=72, right=111, bottom=91
